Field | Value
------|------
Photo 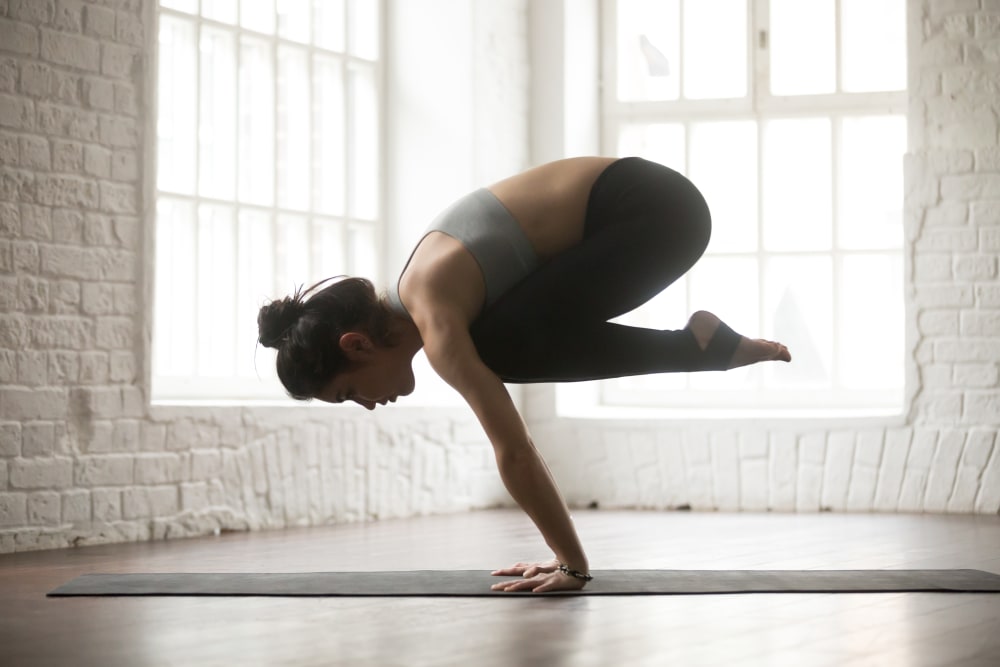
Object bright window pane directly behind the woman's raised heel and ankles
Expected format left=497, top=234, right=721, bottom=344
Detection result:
left=688, top=257, right=760, bottom=390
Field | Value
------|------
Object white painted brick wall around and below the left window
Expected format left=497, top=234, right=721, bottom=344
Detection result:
left=0, top=0, right=527, bottom=553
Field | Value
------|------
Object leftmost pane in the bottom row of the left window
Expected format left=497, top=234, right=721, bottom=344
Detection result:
left=153, top=197, right=197, bottom=376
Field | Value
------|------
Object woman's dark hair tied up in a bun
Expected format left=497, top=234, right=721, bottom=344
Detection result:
left=257, top=276, right=392, bottom=400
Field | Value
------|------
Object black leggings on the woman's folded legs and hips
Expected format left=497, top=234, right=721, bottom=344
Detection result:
left=470, top=158, right=712, bottom=383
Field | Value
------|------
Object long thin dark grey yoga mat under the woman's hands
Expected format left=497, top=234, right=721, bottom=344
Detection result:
left=49, top=570, right=1000, bottom=597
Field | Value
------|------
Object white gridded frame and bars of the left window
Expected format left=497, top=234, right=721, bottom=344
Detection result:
left=147, top=0, right=387, bottom=404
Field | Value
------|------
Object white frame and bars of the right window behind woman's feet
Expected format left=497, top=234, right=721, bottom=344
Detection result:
left=596, top=0, right=907, bottom=416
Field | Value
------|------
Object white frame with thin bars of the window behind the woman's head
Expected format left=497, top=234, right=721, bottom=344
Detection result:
left=151, top=0, right=386, bottom=403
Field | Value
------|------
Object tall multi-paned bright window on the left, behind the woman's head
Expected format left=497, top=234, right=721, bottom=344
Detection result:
left=153, top=0, right=381, bottom=400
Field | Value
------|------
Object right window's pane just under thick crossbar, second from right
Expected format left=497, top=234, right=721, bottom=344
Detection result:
left=761, top=118, right=833, bottom=250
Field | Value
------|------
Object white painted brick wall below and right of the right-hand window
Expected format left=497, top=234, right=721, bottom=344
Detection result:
left=528, top=0, right=1000, bottom=513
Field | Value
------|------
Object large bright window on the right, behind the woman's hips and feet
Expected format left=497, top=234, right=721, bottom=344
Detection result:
left=600, top=0, right=906, bottom=414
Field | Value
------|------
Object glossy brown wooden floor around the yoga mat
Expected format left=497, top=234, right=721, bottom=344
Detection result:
left=0, top=511, right=1000, bottom=667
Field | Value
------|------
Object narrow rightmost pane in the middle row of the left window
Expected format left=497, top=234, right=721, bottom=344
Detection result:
left=350, top=67, right=379, bottom=220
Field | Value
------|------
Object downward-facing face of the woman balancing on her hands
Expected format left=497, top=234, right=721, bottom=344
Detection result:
left=316, top=346, right=416, bottom=410
